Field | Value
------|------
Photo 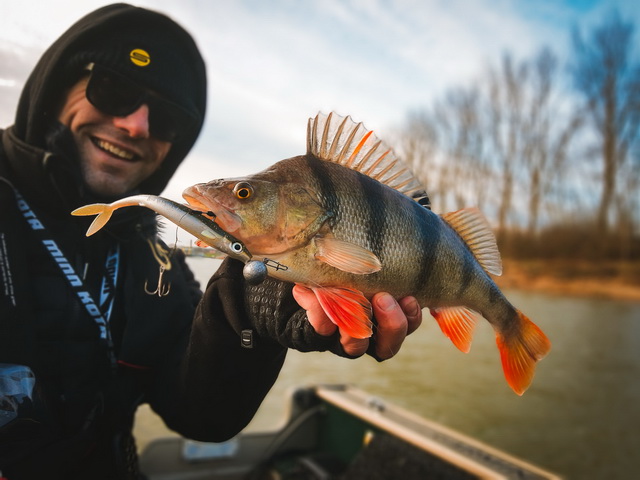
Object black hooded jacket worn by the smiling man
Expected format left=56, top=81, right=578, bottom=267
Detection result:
left=0, top=5, right=288, bottom=480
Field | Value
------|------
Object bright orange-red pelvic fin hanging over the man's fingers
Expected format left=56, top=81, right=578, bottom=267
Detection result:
left=311, top=287, right=373, bottom=338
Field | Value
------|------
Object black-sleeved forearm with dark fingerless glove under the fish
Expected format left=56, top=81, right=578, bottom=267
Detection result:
left=144, top=259, right=356, bottom=441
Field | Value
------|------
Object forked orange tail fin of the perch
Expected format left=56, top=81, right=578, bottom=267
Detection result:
left=496, top=311, right=551, bottom=395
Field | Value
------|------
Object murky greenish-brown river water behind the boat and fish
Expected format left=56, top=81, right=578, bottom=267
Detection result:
left=136, top=258, right=640, bottom=480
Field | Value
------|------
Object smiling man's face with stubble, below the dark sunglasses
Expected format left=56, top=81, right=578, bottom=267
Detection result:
left=58, top=77, right=171, bottom=197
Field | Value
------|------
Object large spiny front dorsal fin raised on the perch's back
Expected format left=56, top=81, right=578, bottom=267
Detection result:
left=307, top=112, right=431, bottom=209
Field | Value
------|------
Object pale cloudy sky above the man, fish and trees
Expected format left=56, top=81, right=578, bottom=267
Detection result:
left=0, top=0, right=640, bottom=200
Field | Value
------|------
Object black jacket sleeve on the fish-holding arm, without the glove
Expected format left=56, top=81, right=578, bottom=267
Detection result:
left=149, top=256, right=286, bottom=441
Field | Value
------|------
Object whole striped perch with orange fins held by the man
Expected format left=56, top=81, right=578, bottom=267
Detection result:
left=183, top=114, right=550, bottom=395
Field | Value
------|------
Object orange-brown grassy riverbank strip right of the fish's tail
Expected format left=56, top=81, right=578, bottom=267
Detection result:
left=493, top=259, right=640, bottom=302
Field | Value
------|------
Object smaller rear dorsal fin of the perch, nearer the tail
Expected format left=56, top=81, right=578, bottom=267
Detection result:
left=442, top=208, right=502, bottom=275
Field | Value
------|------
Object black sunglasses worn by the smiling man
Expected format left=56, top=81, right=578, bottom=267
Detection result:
left=85, top=63, right=197, bottom=142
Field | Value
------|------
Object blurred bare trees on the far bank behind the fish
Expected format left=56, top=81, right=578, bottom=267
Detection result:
left=397, top=12, right=640, bottom=260
